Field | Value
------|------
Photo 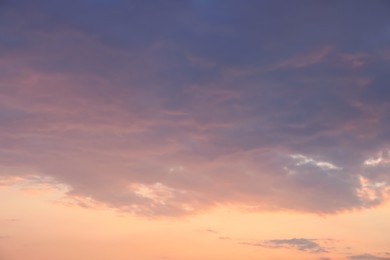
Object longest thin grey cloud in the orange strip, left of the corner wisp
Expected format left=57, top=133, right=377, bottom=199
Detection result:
left=245, top=238, right=328, bottom=253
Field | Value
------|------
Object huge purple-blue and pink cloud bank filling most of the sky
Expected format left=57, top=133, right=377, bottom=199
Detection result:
left=0, top=0, right=390, bottom=217
